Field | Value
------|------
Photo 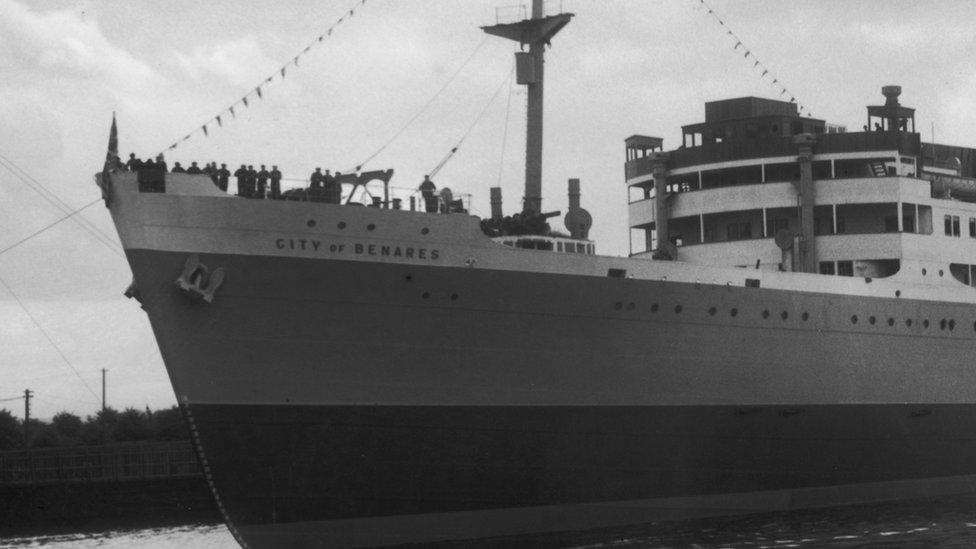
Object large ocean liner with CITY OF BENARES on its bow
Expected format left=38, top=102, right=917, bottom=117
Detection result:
left=96, top=0, right=976, bottom=547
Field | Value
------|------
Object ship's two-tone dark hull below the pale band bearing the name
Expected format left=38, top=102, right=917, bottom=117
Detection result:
left=127, top=245, right=976, bottom=547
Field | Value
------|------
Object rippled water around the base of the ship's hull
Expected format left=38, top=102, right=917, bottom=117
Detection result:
left=0, top=496, right=976, bottom=549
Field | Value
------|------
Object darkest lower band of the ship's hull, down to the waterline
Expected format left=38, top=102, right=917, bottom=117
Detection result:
left=191, top=405, right=976, bottom=547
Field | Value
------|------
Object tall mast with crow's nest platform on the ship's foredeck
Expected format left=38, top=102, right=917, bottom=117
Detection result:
left=481, top=0, right=573, bottom=213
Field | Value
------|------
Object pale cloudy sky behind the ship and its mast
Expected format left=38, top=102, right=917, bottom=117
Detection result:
left=0, top=0, right=976, bottom=418
